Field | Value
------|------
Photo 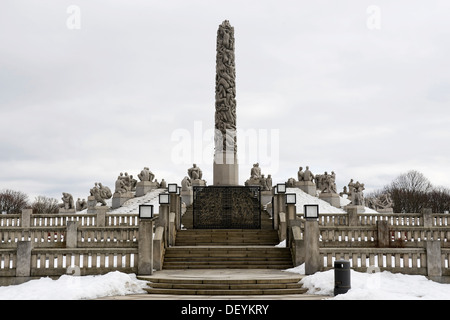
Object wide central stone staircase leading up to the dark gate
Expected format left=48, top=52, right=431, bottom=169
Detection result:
left=142, top=207, right=306, bottom=296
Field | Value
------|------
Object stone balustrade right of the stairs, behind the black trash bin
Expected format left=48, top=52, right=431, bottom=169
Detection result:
left=284, top=208, right=450, bottom=279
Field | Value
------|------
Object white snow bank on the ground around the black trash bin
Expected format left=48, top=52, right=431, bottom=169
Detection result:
left=285, top=264, right=450, bottom=300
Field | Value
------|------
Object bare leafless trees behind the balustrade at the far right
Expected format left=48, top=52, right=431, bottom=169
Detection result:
left=366, top=170, right=450, bottom=213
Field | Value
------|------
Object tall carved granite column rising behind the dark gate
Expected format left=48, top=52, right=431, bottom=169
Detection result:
left=213, top=20, right=239, bottom=186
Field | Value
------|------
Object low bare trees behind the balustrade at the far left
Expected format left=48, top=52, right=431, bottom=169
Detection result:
left=0, top=189, right=59, bottom=214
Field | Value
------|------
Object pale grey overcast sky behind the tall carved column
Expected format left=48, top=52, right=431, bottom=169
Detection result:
left=0, top=0, right=450, bottom=200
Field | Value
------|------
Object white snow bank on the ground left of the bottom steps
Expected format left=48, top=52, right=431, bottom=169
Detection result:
left=0, top=271, right=147, bottom=300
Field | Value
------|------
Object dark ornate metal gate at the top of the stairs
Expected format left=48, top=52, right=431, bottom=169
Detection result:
left=193, top=186, right=261, bottom=229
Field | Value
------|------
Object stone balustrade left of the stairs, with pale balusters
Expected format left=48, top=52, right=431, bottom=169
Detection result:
left=0, top=195, right=181, bottom=285
